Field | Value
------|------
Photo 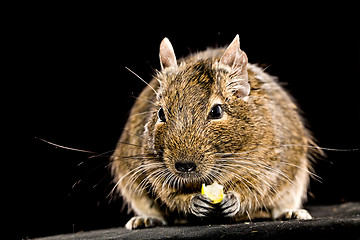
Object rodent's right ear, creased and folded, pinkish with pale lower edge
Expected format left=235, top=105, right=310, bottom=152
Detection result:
left=220, top=35, right=250, bottom=98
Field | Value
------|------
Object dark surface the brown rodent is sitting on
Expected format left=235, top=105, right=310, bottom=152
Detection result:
left=38, top=203, right=360, bottom=240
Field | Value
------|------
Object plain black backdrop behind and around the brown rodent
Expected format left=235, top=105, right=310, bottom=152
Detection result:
left=9, top=2, right=360, bottom=238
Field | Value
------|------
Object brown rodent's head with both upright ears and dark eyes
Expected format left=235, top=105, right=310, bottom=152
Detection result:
left=144, top=36, right=251, bottom=191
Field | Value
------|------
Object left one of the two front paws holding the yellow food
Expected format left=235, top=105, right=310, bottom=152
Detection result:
left=190, top=193, right=215, bottom=217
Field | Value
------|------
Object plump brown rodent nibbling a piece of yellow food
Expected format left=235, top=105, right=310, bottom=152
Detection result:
left=111, top=35, right=316, bottom=229
